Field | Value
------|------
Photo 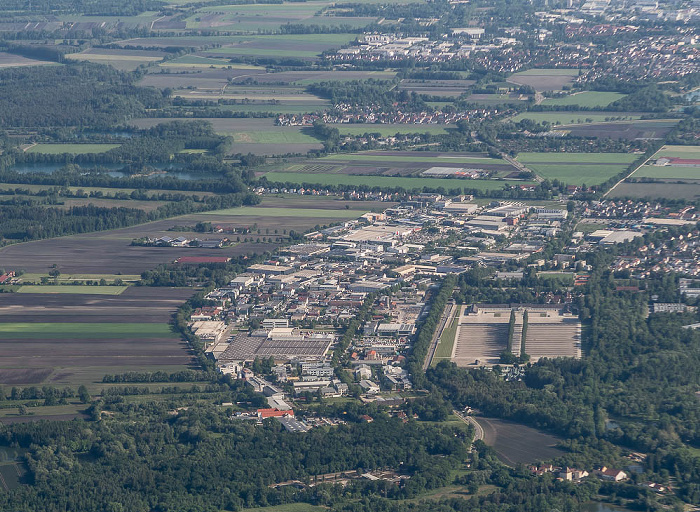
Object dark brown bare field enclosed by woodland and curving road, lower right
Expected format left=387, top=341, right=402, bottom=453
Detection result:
left=475, top=417, right=564, bottom=466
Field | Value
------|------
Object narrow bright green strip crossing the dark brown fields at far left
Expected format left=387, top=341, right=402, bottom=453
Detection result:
left=0, top=322, right=178, bottom=339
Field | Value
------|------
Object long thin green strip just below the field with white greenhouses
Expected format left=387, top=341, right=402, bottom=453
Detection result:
left=262, top=172, right=530, bottom=192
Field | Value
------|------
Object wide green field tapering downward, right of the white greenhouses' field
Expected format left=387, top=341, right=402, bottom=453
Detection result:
left=517, top=153, right=639, bottom=185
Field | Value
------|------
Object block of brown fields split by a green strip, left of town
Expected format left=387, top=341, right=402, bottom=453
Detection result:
left=0, top=286, right=193, bottom=386
